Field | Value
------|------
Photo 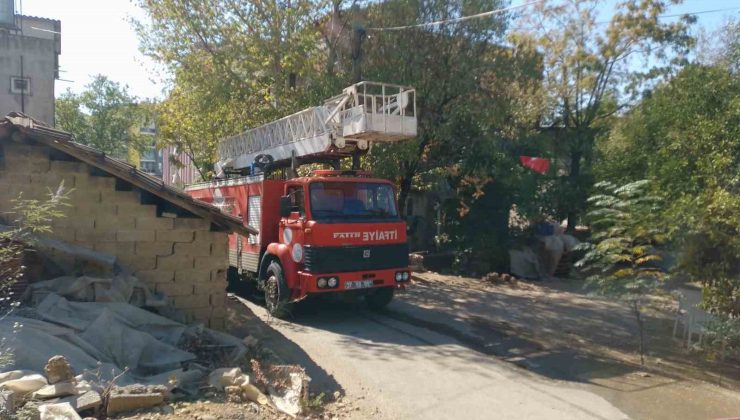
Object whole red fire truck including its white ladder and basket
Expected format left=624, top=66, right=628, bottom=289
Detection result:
left=186, top=82, right=416, bottom=317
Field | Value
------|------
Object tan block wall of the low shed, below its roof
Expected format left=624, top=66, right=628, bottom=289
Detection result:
left=0, top=141, right=228, bottom=329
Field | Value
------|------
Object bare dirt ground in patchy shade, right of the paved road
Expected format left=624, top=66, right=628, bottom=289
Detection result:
left=402, top=272, right=740, bottom=390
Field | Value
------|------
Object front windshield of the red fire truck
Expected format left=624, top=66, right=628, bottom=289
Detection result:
left=310, top=181, right=398, bottom=220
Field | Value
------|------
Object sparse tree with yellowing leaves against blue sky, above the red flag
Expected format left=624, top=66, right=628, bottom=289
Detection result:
left=519, top=0, right=693, bottom=230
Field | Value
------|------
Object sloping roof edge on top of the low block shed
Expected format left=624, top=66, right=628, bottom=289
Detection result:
left=0, top=112, right=259, bottom=236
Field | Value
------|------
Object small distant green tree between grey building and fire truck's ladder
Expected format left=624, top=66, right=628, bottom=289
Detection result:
left=56, top=75, right=142, bottom=159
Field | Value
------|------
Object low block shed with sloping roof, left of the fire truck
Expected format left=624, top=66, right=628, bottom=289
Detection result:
left=0, top=113, right=257, bottom=329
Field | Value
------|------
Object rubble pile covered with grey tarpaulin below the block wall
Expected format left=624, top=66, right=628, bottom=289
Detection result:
left=0, top=251, right=309, bottom=420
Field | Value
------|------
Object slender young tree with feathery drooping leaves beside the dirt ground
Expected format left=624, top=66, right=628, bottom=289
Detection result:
left=576, top=180, right=666, bottom=364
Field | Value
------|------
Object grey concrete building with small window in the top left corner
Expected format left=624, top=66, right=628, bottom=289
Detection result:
left=0, top=9, right=62, bottom=125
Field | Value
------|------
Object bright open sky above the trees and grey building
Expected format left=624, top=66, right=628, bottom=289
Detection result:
left=16, top=0, right=740, bottom=99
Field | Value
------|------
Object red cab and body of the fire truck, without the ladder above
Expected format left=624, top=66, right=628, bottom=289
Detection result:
left=186, top=171, right=410, bottom=312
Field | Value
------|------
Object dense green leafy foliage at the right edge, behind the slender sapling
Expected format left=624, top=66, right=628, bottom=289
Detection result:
left=597, top=65, right=740, bottom=315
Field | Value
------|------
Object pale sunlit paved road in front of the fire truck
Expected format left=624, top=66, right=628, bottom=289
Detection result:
left=241, top=300, right=627, bottom=419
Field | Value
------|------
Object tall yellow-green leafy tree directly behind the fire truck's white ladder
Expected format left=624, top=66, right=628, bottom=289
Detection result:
left=134, top=0, right=333, bottom=178
